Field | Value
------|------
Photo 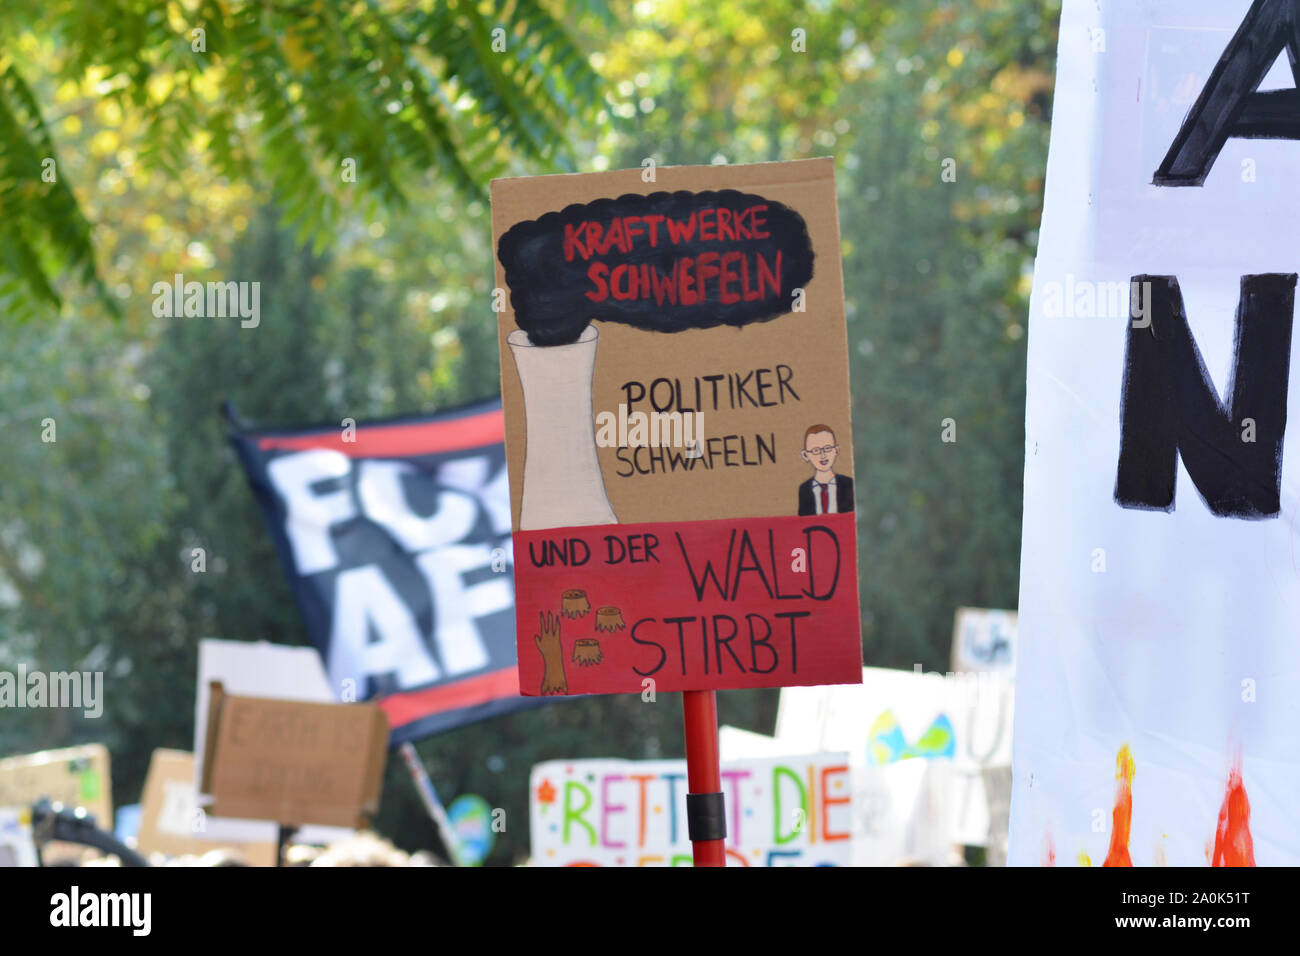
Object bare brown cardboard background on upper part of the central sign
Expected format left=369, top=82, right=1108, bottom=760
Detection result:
left=491, top=159, right=853, bottom=529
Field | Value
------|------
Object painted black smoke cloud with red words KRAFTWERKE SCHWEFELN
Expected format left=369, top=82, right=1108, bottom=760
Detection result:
left=497, top=190, right=814, bottom=346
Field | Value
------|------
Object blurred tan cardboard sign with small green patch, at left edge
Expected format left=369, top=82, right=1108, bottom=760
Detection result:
left=0, top=744, right=113, bottom=830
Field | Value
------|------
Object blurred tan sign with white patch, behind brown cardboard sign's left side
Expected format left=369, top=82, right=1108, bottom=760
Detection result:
left=137, top=748, right=276, bottom=866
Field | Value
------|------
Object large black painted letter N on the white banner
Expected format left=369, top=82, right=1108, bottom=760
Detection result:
left=1115, top=274, right=1296, bottom=518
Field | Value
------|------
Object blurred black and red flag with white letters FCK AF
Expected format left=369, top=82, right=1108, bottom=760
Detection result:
left=230, top=401, right=533, bottom=745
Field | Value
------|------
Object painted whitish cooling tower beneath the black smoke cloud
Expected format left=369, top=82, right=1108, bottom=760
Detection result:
left=506, top=325, right=619, bottom=531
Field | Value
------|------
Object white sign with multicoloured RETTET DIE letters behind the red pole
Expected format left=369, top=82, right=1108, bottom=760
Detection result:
left=529, top=753, right=850, bottom=866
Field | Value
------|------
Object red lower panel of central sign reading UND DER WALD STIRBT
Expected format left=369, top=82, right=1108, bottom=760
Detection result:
left=515, top=514, right=862, bottom=696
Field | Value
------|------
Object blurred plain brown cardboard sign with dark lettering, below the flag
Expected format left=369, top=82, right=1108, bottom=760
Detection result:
left=200, top=682, right=389, bottom=826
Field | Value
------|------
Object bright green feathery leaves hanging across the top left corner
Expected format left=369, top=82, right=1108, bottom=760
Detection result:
left=0, top=0, right=603, bottom=321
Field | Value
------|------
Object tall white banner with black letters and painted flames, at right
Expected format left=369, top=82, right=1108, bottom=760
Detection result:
left=1009, top=0, right=1300, bottom=866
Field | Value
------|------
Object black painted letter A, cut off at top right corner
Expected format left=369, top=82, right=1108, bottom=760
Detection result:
left=1153, top=0, right=1300, bottom=186
